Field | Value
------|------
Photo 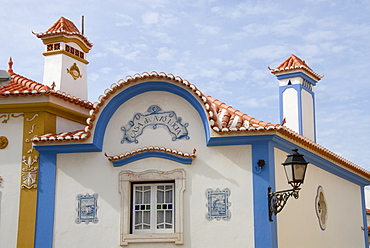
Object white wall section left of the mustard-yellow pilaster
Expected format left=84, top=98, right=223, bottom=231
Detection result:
left=0, top=113, right=23, bottom=248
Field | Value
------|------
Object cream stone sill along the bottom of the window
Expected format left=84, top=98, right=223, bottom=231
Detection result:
left=121, top=233, right=184, bottom=245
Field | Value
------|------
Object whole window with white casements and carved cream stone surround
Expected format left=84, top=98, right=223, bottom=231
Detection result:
left=119, top=169, right=185, bottom=245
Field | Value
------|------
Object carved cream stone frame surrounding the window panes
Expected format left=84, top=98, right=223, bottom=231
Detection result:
left=119, top=169, right=185, bottom=246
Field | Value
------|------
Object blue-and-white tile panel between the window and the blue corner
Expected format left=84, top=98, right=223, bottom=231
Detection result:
left=206, top=188, right=231, bottom=220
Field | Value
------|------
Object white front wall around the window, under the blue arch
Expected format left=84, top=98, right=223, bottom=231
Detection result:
left=54, top=92, right=254, bottom=248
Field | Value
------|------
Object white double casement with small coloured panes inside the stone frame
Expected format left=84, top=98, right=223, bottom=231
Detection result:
left=132, top=183, right=174, bottom=233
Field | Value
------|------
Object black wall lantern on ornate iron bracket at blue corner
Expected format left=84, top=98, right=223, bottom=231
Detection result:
left=268, top=149, right=308, bottom=221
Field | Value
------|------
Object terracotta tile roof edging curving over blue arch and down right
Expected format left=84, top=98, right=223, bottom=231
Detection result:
left=32, top=72, right=370, bottom=178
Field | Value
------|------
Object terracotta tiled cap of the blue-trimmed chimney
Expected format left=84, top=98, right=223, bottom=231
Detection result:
left=269, top=54, right=324, bottom=81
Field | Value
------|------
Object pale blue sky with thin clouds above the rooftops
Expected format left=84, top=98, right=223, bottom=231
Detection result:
left=0, top=0, right=370, bottom=170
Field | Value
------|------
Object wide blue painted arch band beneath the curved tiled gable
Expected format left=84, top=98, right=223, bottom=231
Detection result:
left=93, top=81, right=210, bottom=149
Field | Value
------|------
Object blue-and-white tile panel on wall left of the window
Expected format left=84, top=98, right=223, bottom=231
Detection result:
left=76, top=193, right=99, bottom=225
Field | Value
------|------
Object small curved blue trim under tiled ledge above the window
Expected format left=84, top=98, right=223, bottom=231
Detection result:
left=112, top=151, right=193, bottom=167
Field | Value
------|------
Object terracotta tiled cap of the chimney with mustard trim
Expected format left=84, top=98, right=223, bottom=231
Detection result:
left=35, top=17, right=93, bottom=48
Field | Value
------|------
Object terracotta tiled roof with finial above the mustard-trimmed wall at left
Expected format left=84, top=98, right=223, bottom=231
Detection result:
left=0, top=58, right=93, bottom=109
